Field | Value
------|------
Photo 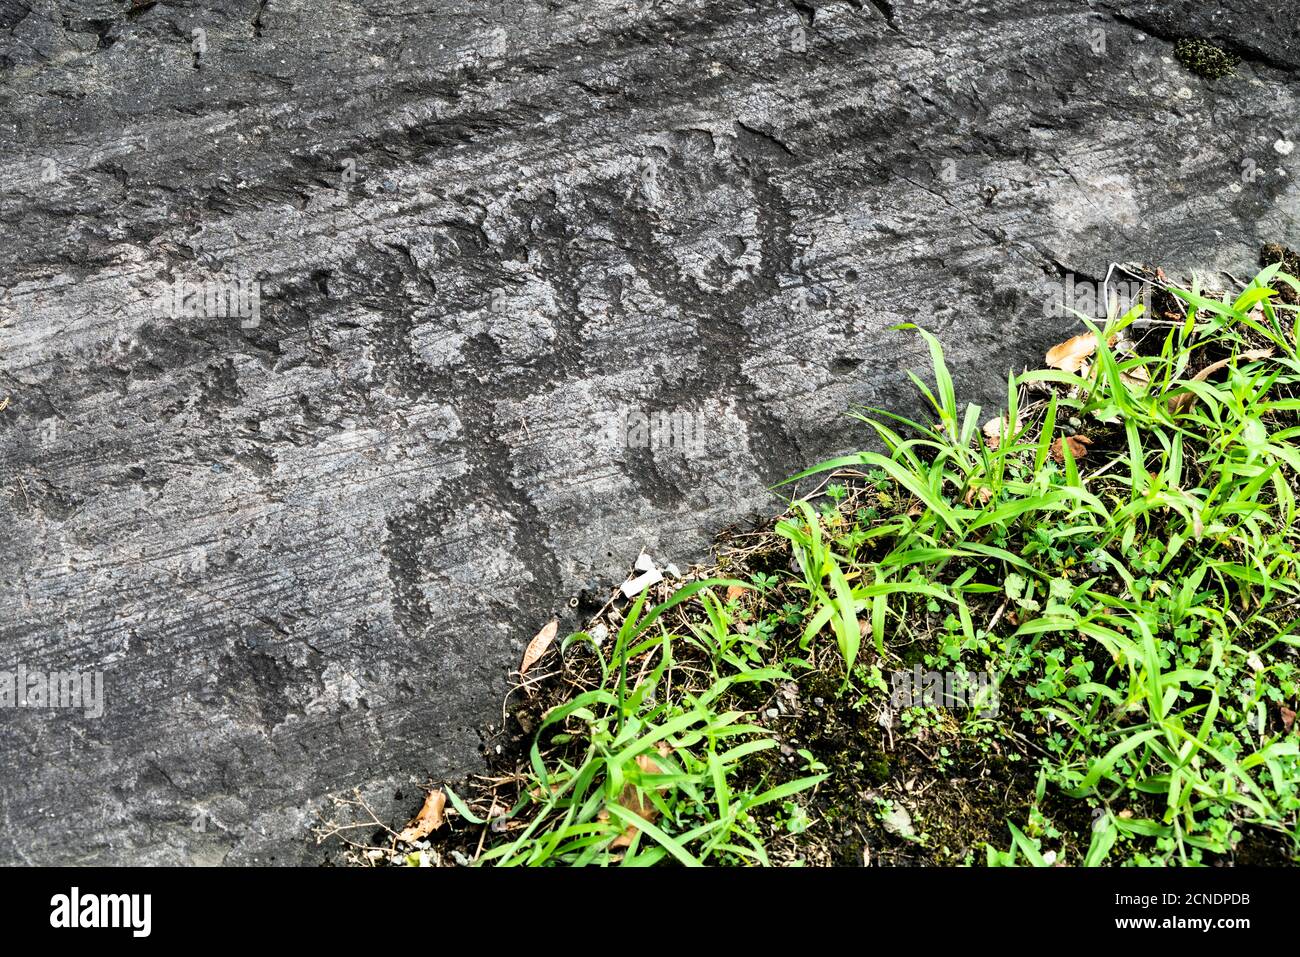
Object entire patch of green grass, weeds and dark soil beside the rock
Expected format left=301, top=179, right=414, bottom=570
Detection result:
left=361, top=264, right=1300, bottom=866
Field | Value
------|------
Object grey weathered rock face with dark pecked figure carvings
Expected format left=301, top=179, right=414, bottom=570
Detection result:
left=0, top=0, right=1300, bottom=863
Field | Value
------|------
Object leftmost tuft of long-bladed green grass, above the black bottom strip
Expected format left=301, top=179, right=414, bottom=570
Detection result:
left=452, top=579, right=822, bottom=867
